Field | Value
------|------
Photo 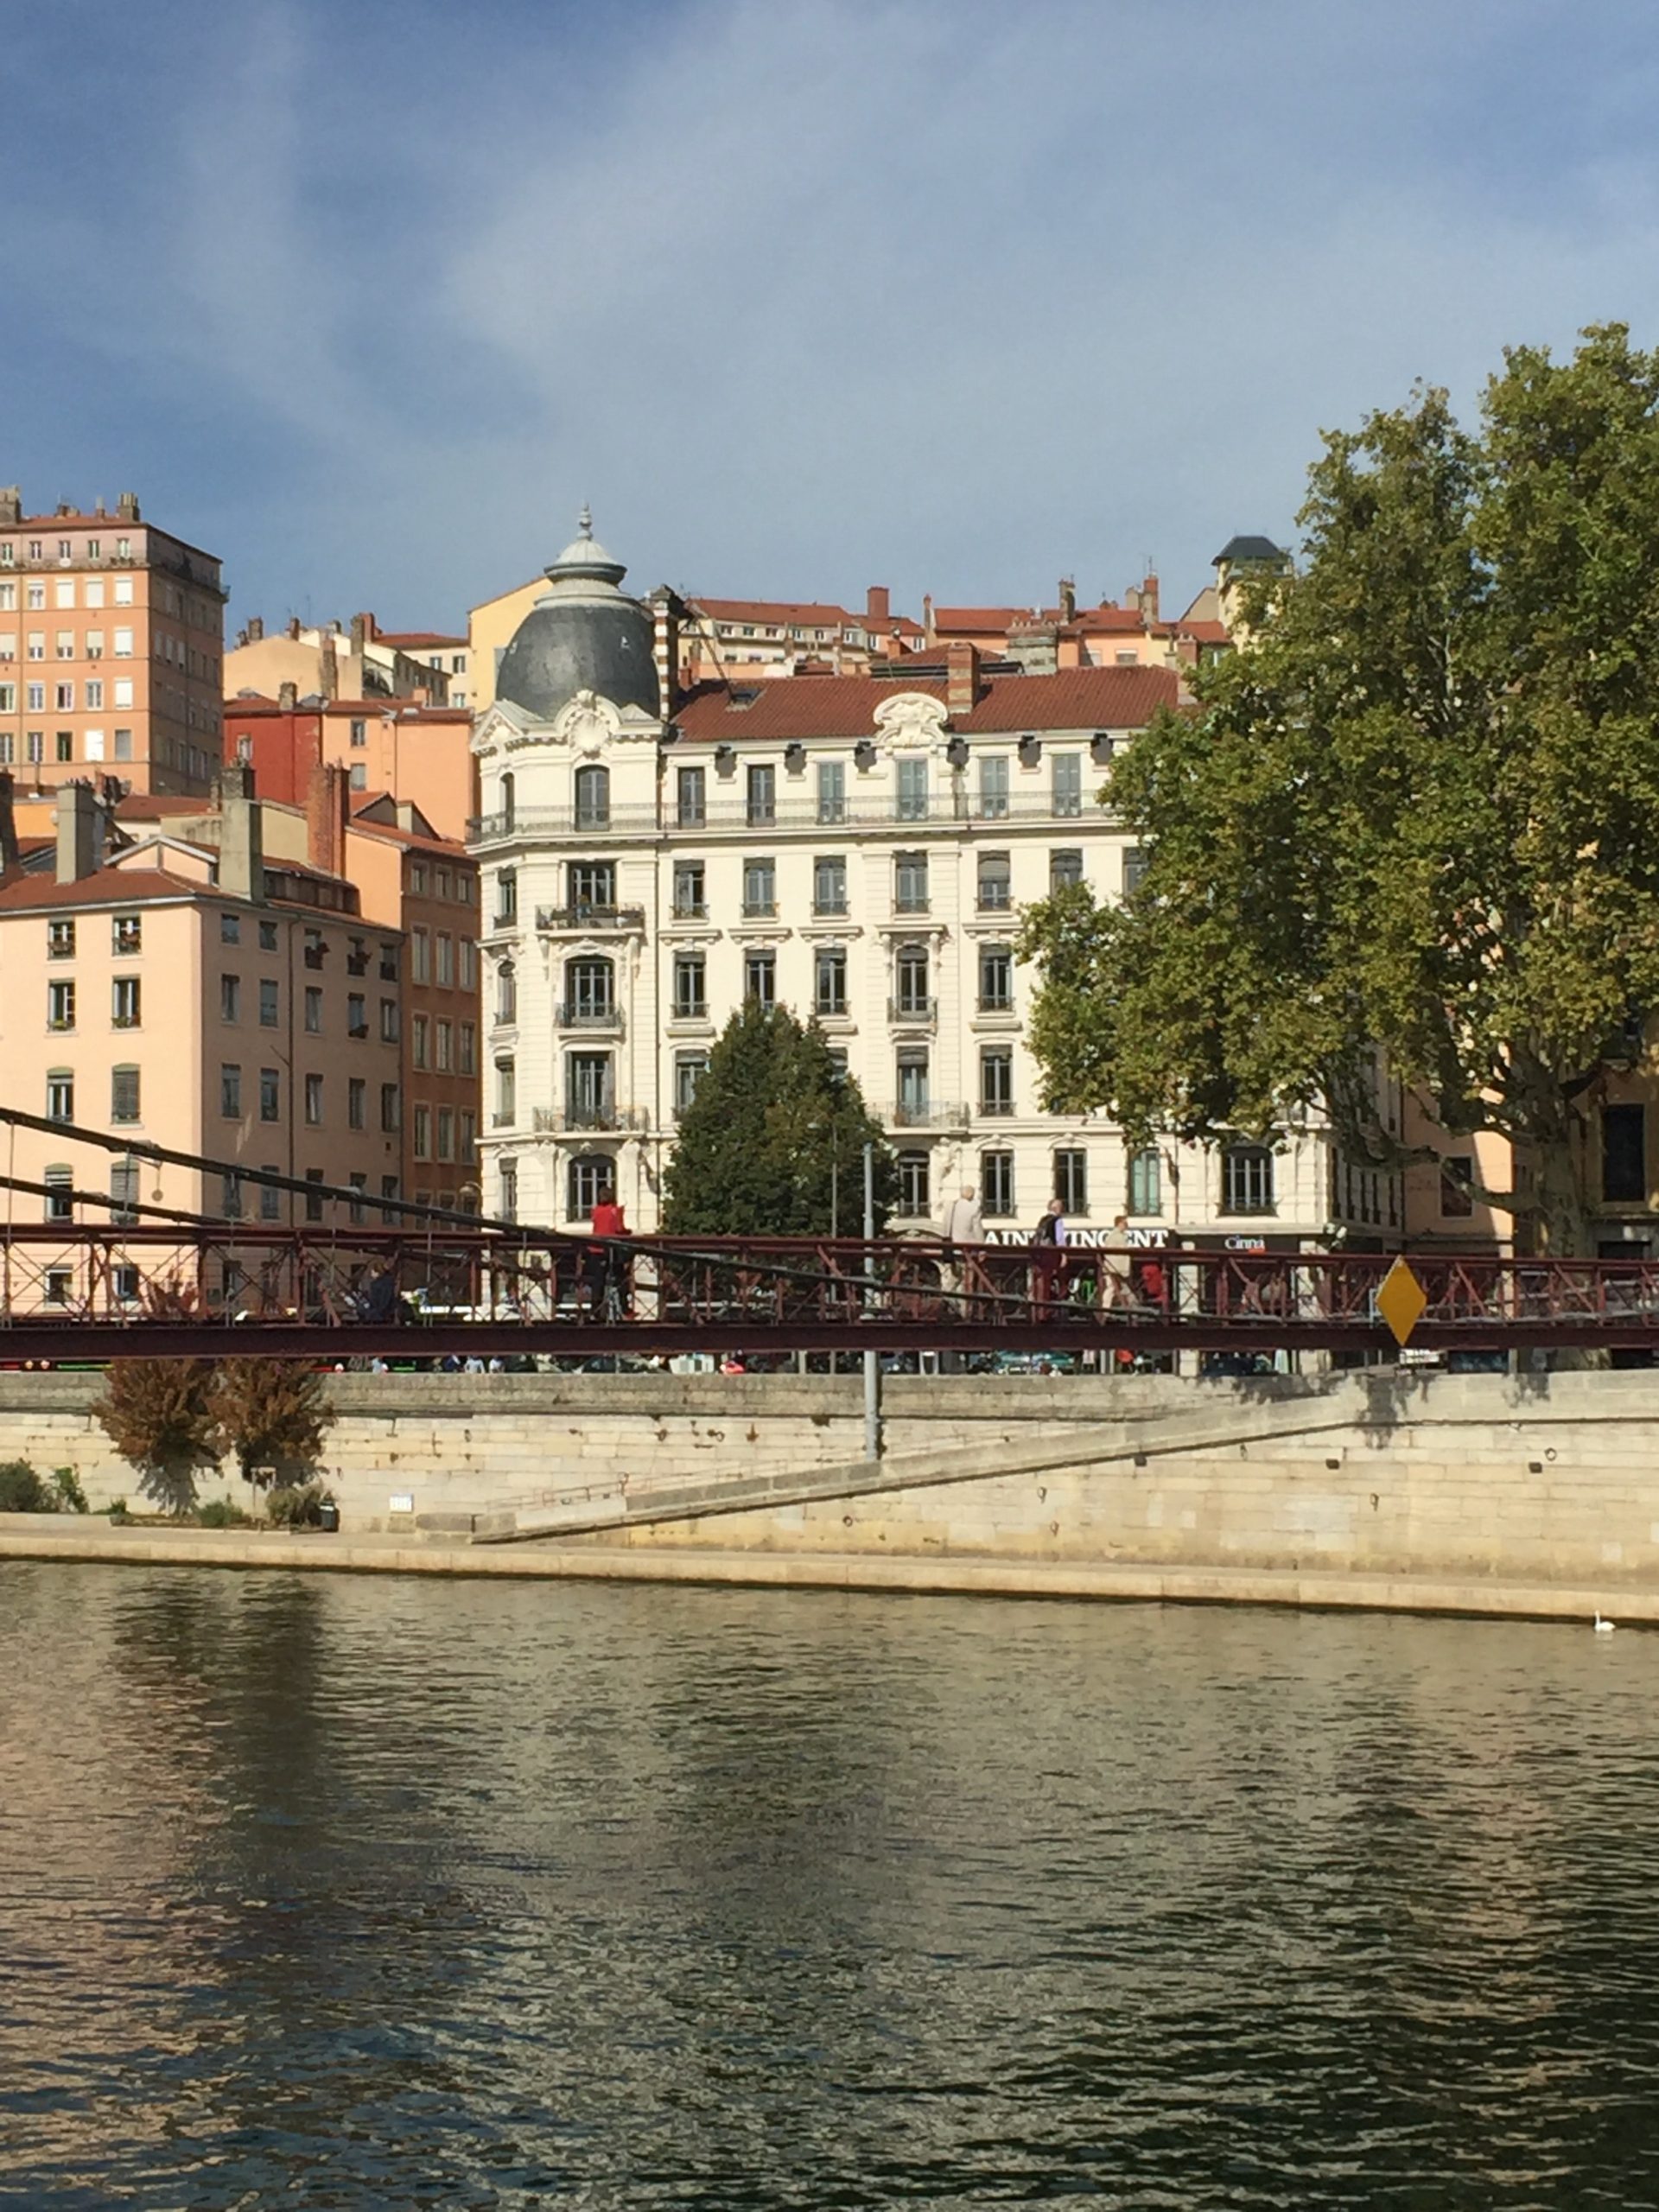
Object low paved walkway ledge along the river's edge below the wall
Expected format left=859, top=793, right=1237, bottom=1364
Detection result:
left=0, top=1513, right=1659, bottom=1628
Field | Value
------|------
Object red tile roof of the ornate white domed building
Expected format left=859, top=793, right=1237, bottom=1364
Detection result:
left=675, top=668, right=1179, bottom=743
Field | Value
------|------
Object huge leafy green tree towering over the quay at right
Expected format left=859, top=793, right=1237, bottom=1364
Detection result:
left=1022, top=325, right=1659, bottom=1252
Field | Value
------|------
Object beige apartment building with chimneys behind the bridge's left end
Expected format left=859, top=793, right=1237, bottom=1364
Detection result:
left=0, top=785, right=404, bottom=1224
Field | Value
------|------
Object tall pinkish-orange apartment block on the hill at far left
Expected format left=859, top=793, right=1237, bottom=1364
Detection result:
left=0, top=486, right=226, bottom=791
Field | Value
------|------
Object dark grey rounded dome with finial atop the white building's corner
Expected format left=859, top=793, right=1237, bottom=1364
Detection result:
left=495, top=506, right=661, bottom=721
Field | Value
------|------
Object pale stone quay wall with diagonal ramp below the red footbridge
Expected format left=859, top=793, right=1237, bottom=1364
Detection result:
left=0, top=1370, right=1659, bottom=1588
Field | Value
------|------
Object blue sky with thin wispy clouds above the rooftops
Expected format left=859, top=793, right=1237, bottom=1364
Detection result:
left=13, top=0, right=1659, bottom=628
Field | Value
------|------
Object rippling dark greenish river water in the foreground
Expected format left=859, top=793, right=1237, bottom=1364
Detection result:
left=0, top=1564, right=1659, bottom=2212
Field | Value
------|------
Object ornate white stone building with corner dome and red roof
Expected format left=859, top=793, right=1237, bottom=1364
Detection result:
left=474, top=515, right=1330, bottom=1248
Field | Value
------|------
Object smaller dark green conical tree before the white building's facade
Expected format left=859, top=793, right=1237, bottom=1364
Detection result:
left=664, top=1000, right=898, bottom=1236
